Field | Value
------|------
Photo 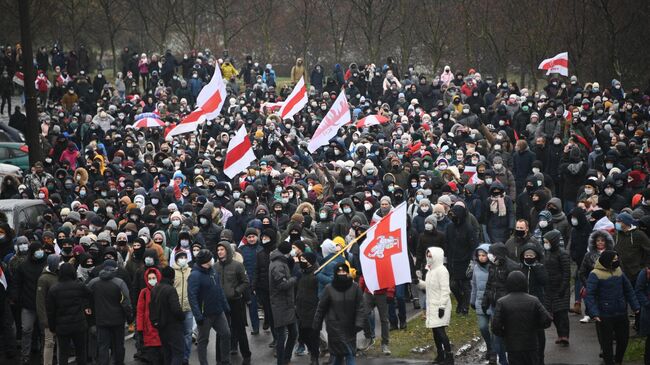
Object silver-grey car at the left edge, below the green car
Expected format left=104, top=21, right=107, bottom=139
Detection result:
left=0, top=199, right=47, bottom=235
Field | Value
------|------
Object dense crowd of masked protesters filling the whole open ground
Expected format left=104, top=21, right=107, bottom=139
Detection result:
left=0, top=42, right=650, bottom=365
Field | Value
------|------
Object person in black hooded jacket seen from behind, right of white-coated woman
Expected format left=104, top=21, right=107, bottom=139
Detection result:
left=491, top=271, right=551, bottom=365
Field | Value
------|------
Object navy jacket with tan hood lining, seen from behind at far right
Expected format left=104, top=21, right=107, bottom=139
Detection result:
left=585, top=261, right=639, bottom=317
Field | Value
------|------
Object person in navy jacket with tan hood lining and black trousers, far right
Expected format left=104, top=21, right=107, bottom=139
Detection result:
left=585, top=250, right=639, bottom=364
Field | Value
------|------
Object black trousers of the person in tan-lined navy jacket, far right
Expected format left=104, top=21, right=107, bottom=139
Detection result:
left=596, top=315, right=630, bottom=365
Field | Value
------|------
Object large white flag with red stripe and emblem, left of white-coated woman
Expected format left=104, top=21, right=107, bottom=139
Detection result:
left=359, top=202, right=411, bottom=292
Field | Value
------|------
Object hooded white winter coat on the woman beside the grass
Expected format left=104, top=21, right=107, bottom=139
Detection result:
left=418, top=247, right=451, bottom=328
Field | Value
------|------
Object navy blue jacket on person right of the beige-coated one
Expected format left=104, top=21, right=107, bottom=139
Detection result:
left=187, top=265, right=230, bottom=322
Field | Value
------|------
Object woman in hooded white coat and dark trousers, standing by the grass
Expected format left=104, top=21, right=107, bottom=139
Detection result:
left=418, top=247, right=454, bottom=364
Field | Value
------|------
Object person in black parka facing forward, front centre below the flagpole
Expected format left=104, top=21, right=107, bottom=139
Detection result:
left=312, top=263, right=368, bottom=363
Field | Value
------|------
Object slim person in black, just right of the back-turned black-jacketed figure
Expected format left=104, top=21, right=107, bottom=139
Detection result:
left=544, top=230, right=571, bottom=346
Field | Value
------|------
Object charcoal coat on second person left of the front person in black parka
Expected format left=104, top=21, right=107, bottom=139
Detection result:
left=269, top=250, right=297, bottom=328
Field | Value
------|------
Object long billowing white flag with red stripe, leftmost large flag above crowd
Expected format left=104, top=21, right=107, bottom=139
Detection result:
left=168, top=67, right=226, bottom=137
